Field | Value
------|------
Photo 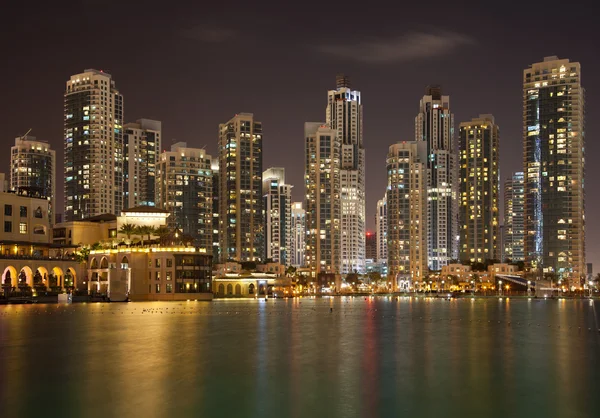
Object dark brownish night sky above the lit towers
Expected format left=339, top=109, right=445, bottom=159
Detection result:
left=0, top=0, right=600, bottom=270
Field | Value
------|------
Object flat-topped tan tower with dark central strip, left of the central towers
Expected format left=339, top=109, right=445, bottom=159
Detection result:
left=219, top=113, right=265, bottom=262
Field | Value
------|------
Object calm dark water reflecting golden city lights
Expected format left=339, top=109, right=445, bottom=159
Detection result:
left=0, top=297, right=600, bottom=418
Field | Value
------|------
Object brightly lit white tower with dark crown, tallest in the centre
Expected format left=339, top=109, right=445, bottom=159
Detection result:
left=327, top=74, right=366, bottom=274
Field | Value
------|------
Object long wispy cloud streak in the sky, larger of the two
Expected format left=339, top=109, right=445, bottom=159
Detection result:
left=318, top=32, right=475, bottom=63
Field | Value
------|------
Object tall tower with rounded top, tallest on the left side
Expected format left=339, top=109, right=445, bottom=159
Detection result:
left=64, top=69, right=123, bottom=222
